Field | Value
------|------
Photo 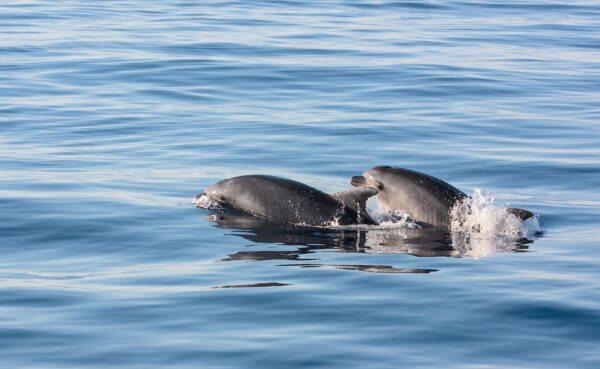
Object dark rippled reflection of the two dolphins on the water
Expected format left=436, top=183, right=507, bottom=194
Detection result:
left=206, top=213, right=533, bottom=273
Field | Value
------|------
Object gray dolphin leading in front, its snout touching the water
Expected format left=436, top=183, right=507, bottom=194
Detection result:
left=196, top=175, right=377, bottom=226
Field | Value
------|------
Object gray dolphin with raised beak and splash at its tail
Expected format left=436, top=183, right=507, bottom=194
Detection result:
left=350, top=166, right=533, bottom=229
